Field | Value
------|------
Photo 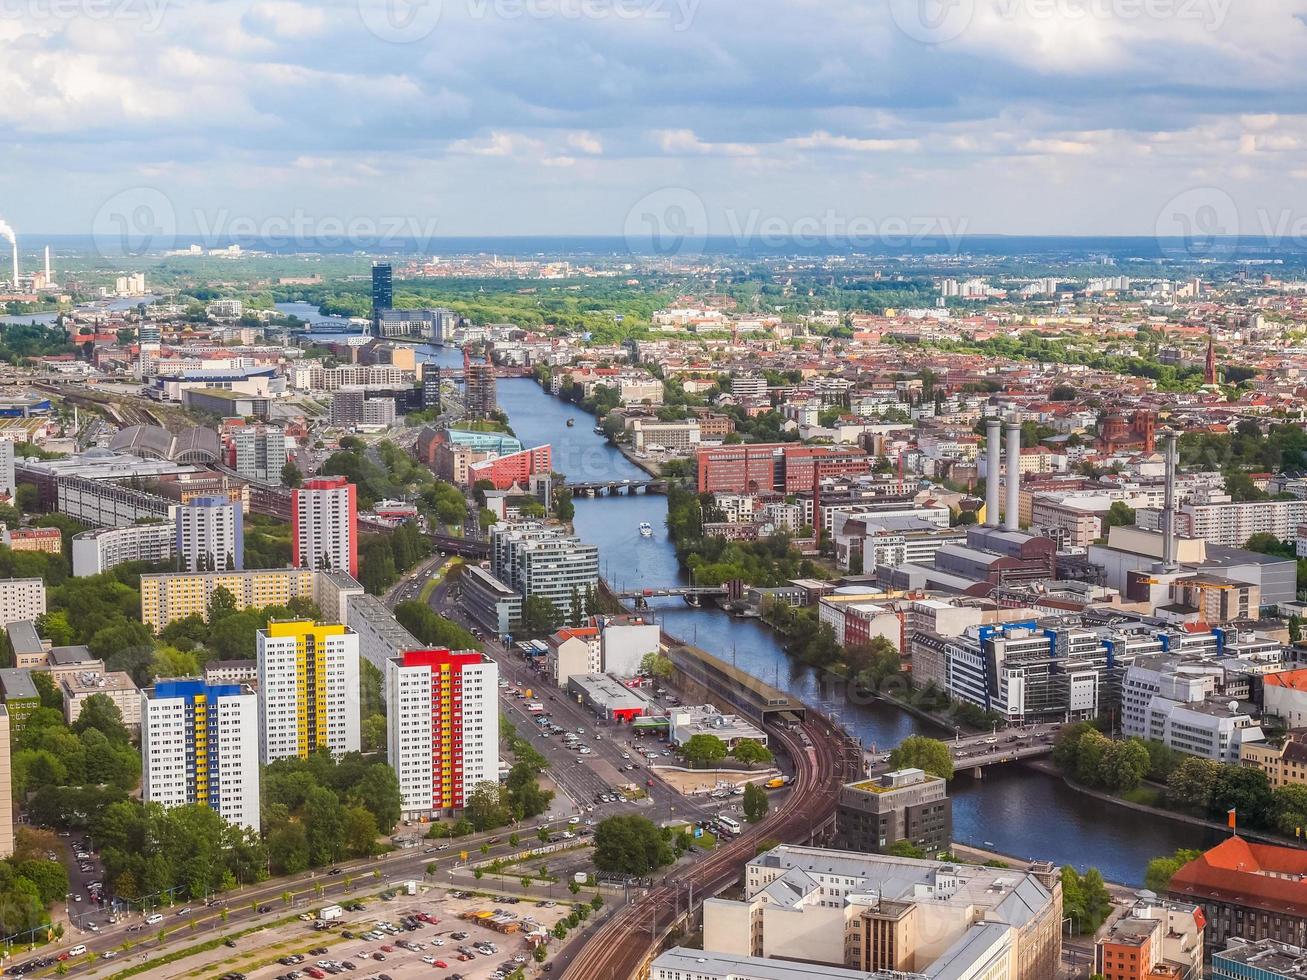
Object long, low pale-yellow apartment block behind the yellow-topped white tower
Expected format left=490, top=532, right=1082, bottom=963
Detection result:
left=140, top=567, right=318, bottom=631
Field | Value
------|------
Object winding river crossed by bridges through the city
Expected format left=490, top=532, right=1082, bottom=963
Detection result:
left=423, top=348, right=1217, bottom=885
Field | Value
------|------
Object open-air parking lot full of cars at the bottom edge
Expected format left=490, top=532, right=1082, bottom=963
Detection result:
left=247, top=892, right=571, bottom=980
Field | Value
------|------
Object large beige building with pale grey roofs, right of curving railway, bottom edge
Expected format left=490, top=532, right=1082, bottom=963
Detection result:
left=703, top=845, right=1061, bottom=980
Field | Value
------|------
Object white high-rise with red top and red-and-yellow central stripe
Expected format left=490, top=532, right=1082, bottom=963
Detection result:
left=386, top=649, right=499, bottom=818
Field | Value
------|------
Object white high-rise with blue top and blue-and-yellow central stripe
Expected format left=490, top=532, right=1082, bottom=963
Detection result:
left=141, top=679, right=259, bottom=831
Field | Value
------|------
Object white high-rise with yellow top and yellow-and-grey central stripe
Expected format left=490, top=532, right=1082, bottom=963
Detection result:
left=256, top=621, right=359, bottom=764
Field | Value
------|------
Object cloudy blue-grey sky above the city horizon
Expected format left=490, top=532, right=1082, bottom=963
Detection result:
left=0, top=0, right=1307, bottom=240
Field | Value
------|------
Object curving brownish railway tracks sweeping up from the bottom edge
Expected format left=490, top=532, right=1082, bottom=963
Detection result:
left=562, top=719, right=860, bottom=980
